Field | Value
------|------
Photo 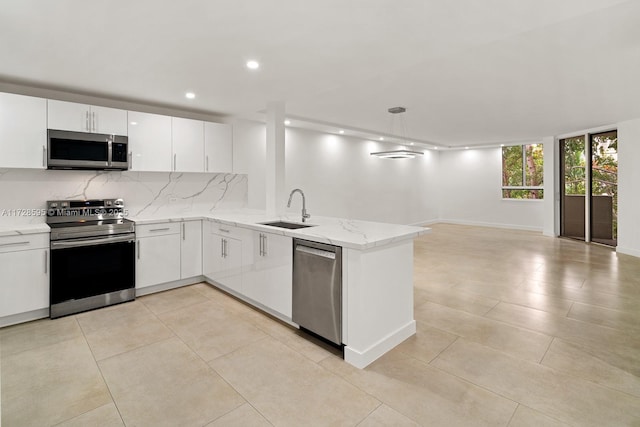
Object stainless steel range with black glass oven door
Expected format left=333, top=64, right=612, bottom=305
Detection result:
left=47, top=199, right=136, bottom=319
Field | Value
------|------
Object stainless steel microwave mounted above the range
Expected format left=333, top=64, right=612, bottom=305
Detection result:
left=47, top=129, right=129, bottom=170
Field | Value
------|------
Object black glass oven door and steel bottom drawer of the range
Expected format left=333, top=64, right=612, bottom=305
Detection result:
left=49, top=234, right=135, bottom=318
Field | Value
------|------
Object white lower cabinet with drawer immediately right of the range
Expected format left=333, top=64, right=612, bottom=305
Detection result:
left=136, top=222, right=181, bottom=289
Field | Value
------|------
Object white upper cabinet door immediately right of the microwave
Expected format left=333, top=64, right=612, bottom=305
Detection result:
left=129, top=111, right=172, bottom=172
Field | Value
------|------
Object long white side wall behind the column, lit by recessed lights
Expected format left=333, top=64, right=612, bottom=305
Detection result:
left=233, top=121, right=439, bottom=224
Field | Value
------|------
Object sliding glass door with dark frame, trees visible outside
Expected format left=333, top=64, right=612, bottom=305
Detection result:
left=560, top=131, right=618, bottom=246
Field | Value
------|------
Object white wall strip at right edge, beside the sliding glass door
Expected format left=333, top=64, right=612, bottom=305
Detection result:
left=617, top=119, right=640, bottom=257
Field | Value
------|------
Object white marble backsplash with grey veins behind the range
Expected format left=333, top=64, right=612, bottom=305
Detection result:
left=0, top=169, right=248, bottom=226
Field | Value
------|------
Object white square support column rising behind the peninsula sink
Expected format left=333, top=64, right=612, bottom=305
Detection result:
left=265, top=101, right=286, bottom=215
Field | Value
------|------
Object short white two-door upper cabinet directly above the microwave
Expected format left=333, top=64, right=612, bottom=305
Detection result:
left=47, top=99, right=127, bottom=135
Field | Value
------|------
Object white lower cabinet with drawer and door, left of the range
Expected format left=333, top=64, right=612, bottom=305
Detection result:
left=0, top=233, right=49, bottom=318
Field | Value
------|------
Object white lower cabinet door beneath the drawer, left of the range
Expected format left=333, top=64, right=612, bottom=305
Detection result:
left=0, top=249, right=49, bottom=317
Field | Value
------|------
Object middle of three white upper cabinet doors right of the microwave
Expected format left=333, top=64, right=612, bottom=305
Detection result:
left=171, top=117, right=204, bottom=172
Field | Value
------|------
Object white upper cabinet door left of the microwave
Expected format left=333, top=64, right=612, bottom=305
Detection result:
left=0, top=93, right=47, bottom=169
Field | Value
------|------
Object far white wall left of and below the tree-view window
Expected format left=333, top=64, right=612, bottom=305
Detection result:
left=439, top=147, right=546, bottom=231
